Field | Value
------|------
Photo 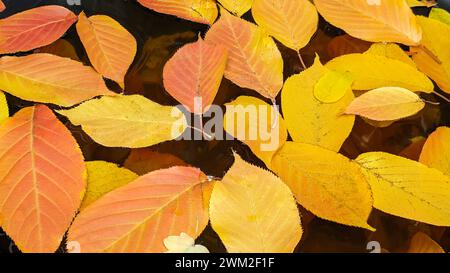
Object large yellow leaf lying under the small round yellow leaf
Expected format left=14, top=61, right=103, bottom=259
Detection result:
left=281, top=58, right=355, bottom=151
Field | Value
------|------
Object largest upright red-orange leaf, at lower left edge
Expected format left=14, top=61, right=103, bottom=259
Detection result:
left=0, top=105, right=86, bottom=252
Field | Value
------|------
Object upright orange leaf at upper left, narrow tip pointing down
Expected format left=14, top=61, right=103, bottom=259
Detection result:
left=77, top=12, right=137, bottom=89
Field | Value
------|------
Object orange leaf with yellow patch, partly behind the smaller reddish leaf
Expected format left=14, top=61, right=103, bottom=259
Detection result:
left=205, top=9, right=283, bottom=99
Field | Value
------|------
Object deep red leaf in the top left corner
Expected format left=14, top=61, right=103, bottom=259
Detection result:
left=0, top=6, right=77, bottom=54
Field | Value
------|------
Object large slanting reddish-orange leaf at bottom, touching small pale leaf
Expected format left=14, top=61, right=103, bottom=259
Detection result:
left=68, top=167, right=212, bottom=252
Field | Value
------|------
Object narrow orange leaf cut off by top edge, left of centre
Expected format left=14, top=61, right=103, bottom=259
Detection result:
left=138, top=0, right=218, bottom=25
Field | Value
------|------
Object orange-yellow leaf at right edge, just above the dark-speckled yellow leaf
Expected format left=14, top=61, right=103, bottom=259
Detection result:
left=419, top=127, right=450, bottom=177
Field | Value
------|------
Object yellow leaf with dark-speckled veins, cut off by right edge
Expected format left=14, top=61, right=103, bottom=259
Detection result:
left=356, top=152, right=450, bottom=226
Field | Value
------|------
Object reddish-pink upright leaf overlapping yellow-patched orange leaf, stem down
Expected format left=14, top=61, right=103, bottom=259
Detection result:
left=163, top=37, right=228, bottom=114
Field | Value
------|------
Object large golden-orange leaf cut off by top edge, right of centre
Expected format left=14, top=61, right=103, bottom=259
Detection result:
left=314, top=0, right=422, bottom=45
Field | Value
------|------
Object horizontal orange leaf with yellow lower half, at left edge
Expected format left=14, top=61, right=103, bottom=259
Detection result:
left=0, top=53, right=115, bottom=106
